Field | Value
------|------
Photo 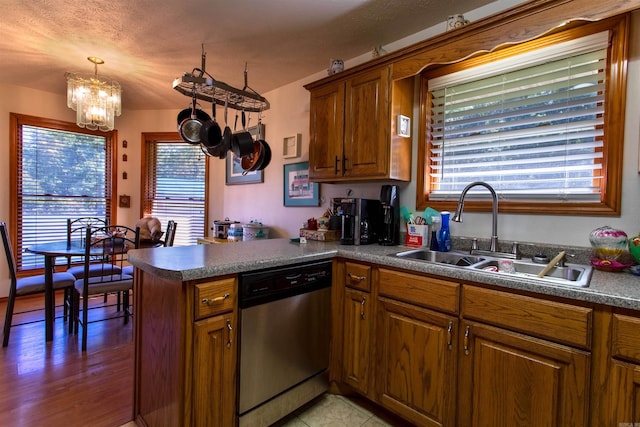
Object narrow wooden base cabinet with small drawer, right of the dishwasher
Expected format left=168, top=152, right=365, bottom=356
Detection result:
left=341, top=262, right=374, bottom=395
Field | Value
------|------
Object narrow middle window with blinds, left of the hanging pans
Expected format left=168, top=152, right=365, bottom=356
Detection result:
left=142, top=133, right=208, bottom=246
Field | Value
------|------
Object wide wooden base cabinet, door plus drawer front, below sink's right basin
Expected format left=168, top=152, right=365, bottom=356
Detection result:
left=458, top=286, right=592, bottom=426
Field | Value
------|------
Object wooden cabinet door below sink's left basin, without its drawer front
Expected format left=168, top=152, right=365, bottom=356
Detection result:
left=375, top=298, right=460, bottom=426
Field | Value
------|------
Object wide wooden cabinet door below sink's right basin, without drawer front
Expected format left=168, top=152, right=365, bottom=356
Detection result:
left=458, top=322, right=590, bottom=427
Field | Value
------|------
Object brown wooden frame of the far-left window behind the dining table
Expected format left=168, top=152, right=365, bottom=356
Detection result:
left=9, top=112, right=118, bottom=276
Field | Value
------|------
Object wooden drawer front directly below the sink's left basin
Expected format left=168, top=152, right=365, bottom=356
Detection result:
left=379, top=268, right=460, bottom=314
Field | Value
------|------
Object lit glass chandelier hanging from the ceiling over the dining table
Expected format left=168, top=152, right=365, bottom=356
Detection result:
left=65, top=56, right=122, bottom=132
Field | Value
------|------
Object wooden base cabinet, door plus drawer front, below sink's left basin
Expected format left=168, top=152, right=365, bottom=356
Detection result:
left=375, top=269, right=460, bottom=427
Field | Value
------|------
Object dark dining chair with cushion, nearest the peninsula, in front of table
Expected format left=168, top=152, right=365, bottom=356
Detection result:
left=69, top=225, right=140, bottom=351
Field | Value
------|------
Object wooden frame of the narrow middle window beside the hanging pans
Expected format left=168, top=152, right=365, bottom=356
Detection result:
left=140, top=132, right=211, bottom=247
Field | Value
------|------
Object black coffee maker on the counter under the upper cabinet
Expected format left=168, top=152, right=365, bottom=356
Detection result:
left=333, top=198, right=382, bottom=245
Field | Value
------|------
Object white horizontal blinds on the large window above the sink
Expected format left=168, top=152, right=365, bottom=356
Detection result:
left=428, top=32, right=608, bottom=201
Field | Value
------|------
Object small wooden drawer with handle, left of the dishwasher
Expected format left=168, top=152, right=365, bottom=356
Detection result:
left=195, top=277, right=237, bottom=319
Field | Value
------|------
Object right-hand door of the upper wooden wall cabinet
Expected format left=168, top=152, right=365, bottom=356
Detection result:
left=343, top=67, right=391, bottom=178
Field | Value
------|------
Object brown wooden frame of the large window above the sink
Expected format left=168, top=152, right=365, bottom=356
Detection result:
left=416, top=14, right=630, bottom=216
